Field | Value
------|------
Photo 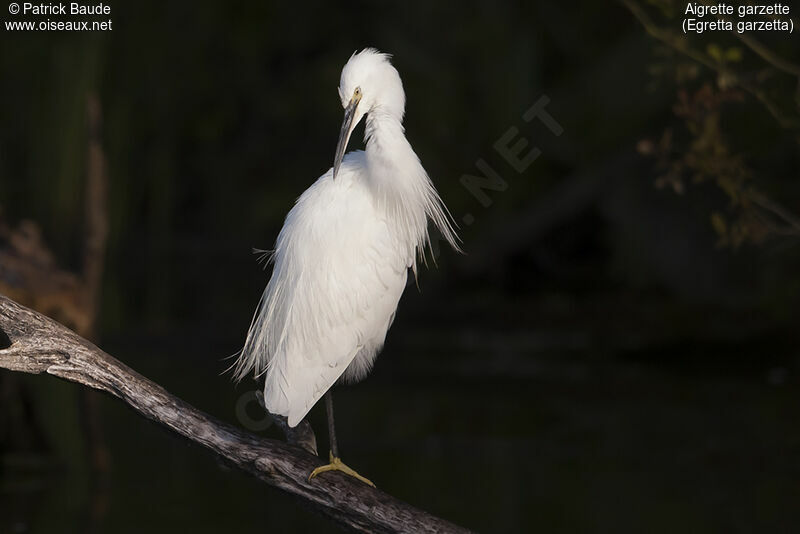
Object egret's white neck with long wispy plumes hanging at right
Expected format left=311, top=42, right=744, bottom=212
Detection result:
left=365, top=111, right=459, bottom=272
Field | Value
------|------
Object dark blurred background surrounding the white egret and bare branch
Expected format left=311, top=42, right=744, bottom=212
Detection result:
left=0, top=1, right=800, bottom=533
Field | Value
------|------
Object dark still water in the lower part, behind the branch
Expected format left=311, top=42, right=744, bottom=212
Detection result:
left=0, top=310, right=800, bottom=533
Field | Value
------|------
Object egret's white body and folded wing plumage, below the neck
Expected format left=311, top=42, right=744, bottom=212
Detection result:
left=231, top=152, right=411, bottom=426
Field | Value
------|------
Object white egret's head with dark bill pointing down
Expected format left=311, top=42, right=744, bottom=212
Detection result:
left=333, top=48, right=406, bottom=179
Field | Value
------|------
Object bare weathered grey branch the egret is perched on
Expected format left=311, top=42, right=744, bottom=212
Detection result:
left=0, top=295, right=476, bottom=533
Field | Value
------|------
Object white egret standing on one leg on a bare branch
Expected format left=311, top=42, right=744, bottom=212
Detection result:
left=235, top=48, right=458, bottom=484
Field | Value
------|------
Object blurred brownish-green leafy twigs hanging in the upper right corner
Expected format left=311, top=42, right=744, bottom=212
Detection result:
left=624, top=0, right=800, bottom=248
